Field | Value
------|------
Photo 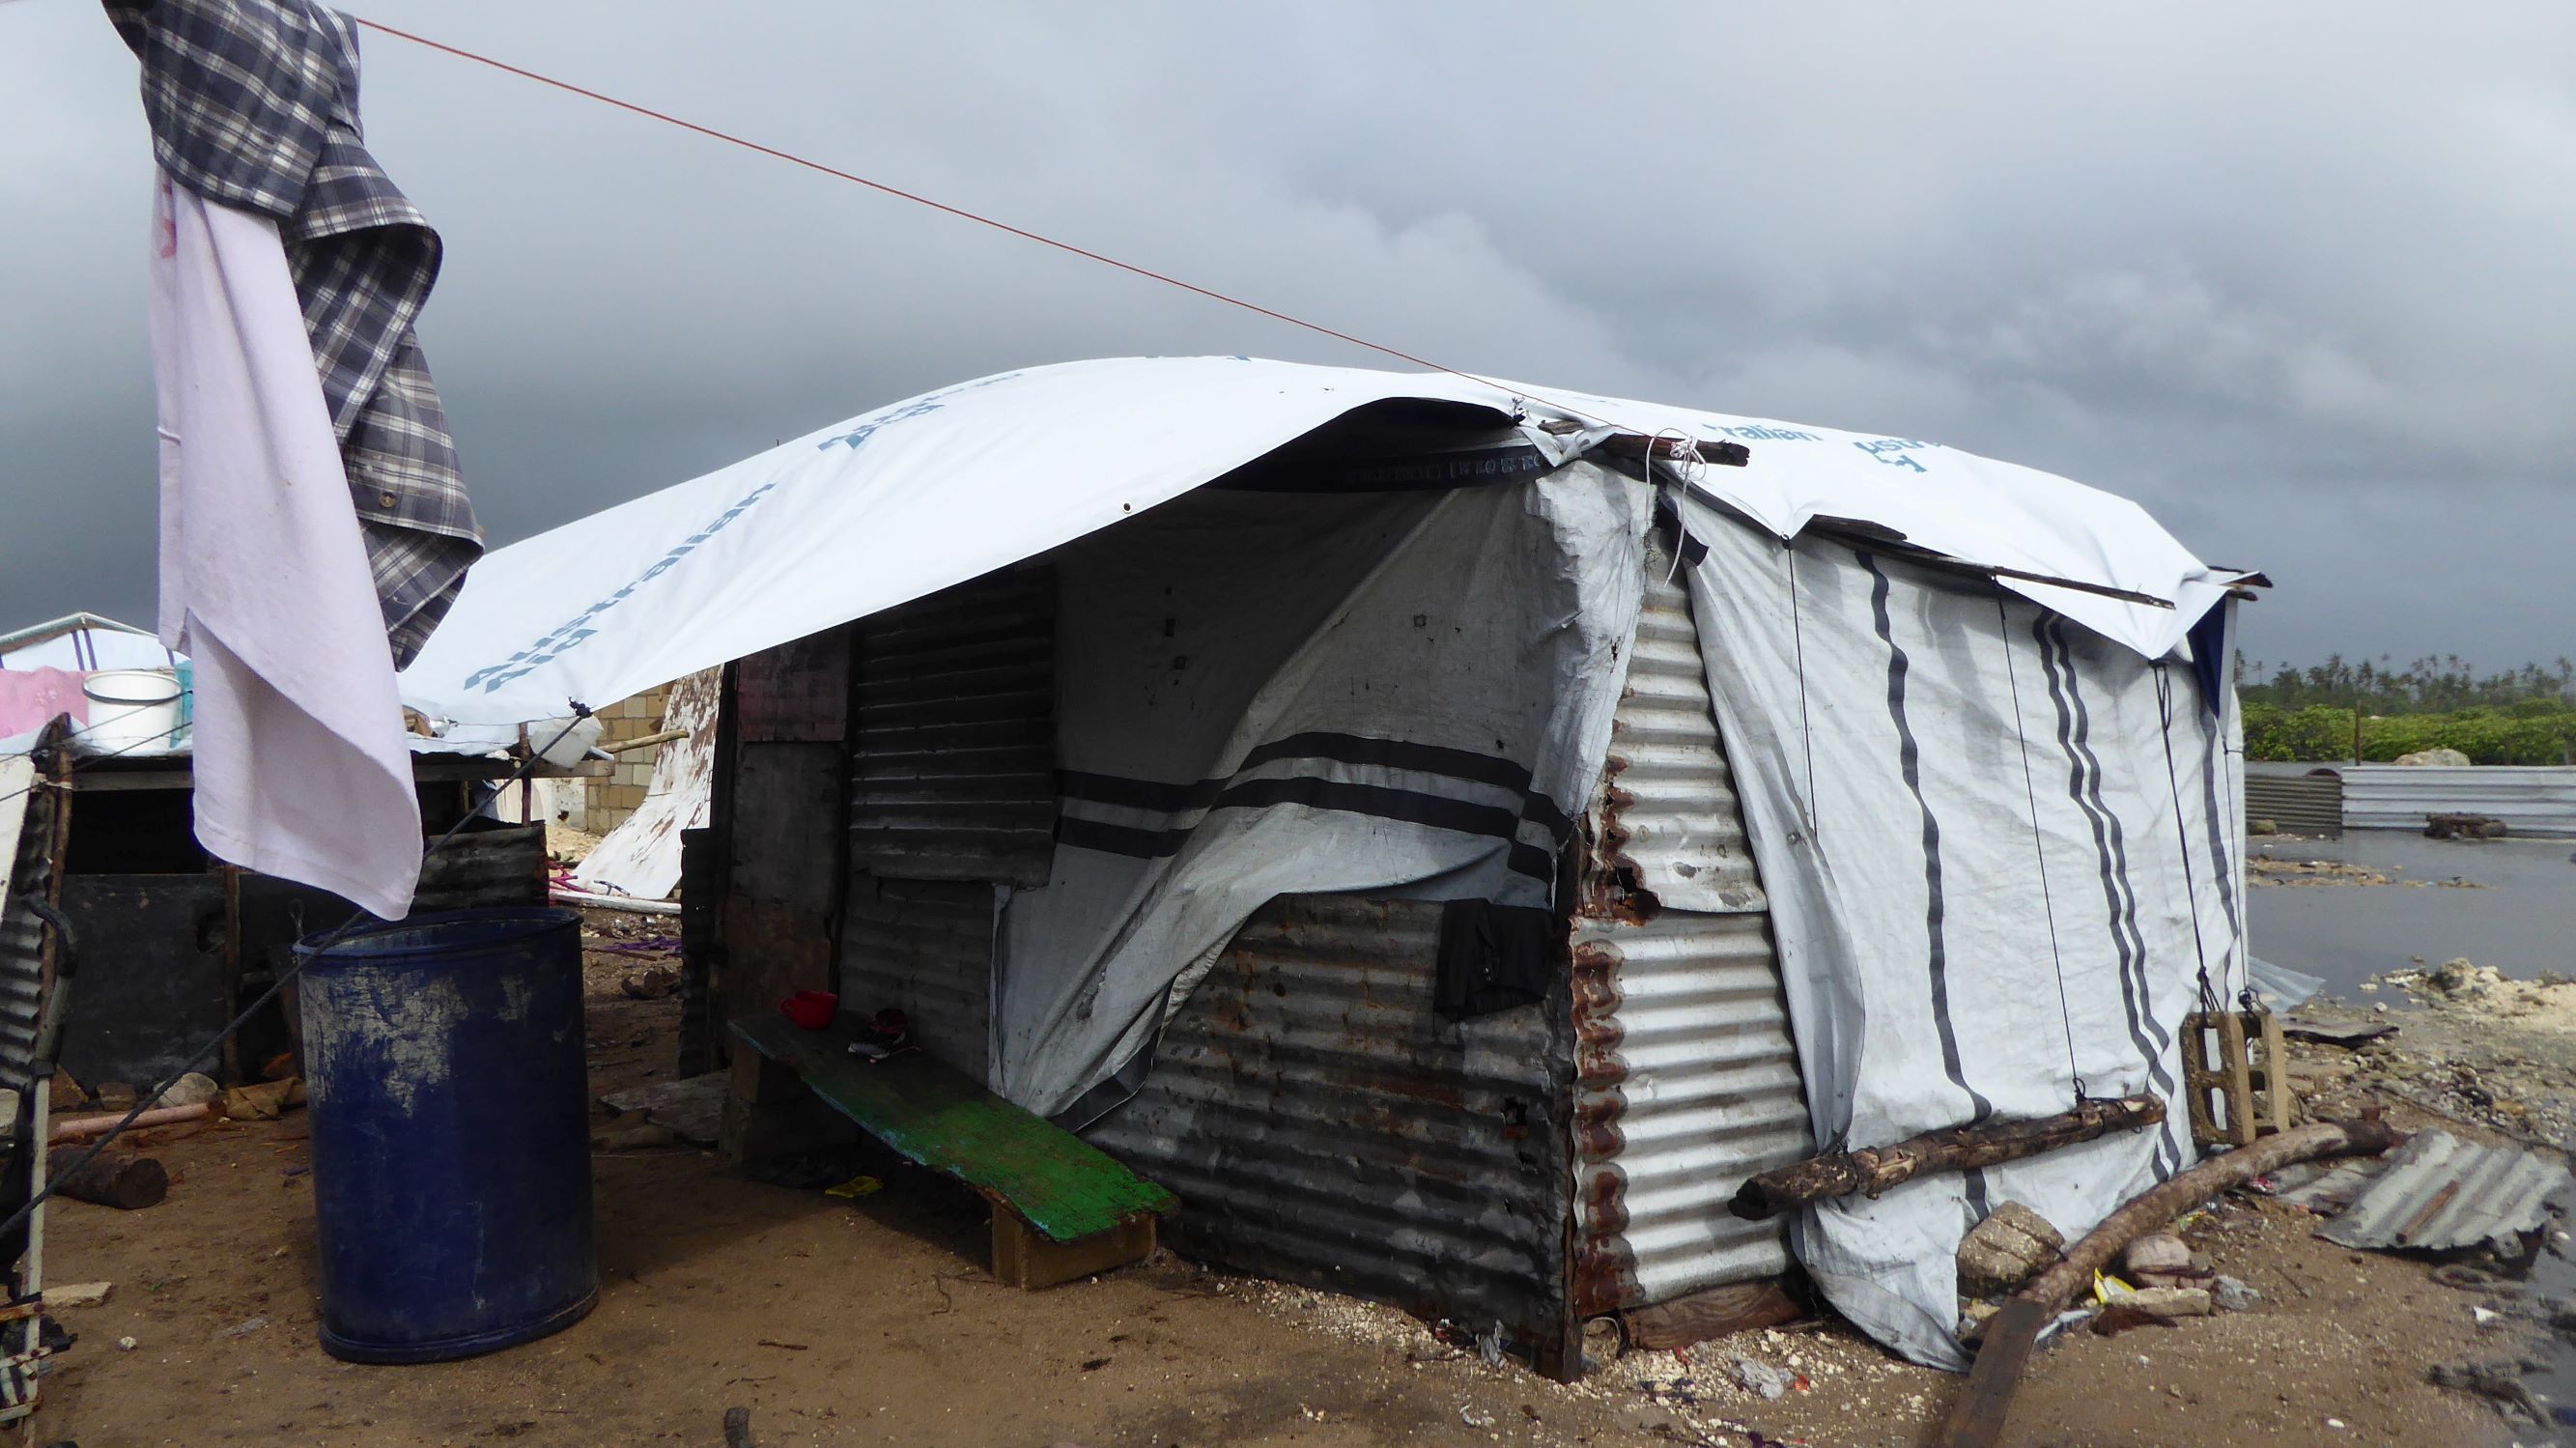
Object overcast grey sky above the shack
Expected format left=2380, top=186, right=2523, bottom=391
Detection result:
left=0, top=0, right=2576, bottom=667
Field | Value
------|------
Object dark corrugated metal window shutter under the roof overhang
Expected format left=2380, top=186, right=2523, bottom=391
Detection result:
left=850, top=567, right=1056, bottom=887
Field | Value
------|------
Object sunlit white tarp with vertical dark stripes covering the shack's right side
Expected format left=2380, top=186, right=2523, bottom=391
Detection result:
left=1683, top=489, right=2247, bottom=1366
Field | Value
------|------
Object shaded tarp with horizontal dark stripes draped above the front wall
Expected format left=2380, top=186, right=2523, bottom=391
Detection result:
left=994, top=464, right=1652, bottom=1121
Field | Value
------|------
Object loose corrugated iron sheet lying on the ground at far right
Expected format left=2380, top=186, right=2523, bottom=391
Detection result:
left=2321, top=1131, right=2568, bottom=1252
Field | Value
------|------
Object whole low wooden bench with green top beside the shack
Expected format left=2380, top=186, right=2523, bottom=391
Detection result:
left=723, top=1015, right=1179, bottom=1289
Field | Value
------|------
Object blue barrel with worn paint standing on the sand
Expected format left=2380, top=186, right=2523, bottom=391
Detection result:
left=297, top=910, right=600, bottom=1363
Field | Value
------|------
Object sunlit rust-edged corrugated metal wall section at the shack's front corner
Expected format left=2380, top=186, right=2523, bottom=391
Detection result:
left=1574, top=559, right=1814, bottom=1317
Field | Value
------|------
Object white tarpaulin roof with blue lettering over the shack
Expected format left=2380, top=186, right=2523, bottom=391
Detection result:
left=402, top=358, right=2241, bottom=724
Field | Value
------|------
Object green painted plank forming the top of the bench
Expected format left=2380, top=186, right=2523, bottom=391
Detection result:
left=731, top=1015, right=1179, bottom=1242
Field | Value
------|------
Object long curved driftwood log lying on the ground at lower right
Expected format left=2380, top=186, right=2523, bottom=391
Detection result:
left=1935, top=1116, right=2403, bottom=1448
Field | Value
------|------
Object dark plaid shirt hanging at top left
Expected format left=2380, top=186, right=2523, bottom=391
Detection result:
left=105, top=0, right=482, bottom=667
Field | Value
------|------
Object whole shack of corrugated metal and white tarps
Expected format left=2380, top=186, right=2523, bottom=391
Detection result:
left=405, top=358, right=2256, bottom=1374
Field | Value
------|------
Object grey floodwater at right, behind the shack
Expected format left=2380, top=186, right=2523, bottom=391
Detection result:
left=2247, top=830, right=2576, bottom=1005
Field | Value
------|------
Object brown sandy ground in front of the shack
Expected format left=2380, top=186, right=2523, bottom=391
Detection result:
left=34, top=920, right=2545, bottom=1448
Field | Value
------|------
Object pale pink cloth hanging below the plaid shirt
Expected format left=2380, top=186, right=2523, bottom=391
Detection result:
left=152, top=175, right=420, bottom=920
